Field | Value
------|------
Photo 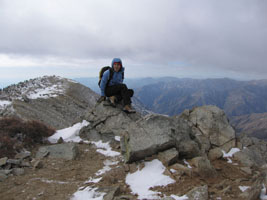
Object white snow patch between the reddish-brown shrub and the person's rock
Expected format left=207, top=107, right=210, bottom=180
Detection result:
left=48, top=120, right=89, bottom=143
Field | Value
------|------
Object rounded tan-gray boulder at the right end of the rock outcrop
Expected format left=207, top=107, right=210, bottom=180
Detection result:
left=180, top=106, right=236, bottom=152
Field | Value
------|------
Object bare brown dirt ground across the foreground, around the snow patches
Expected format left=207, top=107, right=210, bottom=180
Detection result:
left=0, top=144, right=260, bottom=200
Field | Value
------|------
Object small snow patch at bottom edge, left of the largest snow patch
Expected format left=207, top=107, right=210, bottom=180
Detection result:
left=71, top=187, right=106, bottom=200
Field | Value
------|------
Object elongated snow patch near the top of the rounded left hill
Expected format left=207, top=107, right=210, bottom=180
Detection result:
left=27, top=85, right=64, bottom=99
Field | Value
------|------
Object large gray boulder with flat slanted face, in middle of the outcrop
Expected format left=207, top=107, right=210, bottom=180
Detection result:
left=121, top=115, right=176, bottom=162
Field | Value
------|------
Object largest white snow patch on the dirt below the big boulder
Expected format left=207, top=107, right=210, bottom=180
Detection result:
left=125, top=159, right=175, bottom=199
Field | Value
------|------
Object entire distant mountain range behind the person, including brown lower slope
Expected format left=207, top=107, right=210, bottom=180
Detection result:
left=75, top=77, right=267, bottom=138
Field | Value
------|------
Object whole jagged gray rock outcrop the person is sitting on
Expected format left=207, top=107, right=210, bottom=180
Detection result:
left=80, top=103, right=239, bottom=163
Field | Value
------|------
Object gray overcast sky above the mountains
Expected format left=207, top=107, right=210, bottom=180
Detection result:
left=0, top=0, right=267, bottom=85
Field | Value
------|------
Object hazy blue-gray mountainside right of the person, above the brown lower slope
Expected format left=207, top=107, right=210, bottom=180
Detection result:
left=136, top=79, right=267, bottom=116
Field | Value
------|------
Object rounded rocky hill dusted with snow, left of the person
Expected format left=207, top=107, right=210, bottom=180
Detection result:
left=0, top=76, right=98, bottom=129
